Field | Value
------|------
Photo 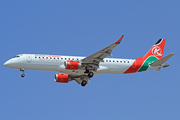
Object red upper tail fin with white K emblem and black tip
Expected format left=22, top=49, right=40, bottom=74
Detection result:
left=143, top=39, right=166, bottom=59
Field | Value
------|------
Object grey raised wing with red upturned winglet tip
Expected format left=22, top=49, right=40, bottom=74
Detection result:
left=82, top=35, right=124, bottom=71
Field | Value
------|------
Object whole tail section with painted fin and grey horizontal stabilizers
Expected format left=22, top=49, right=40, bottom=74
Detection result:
left=124, top=39, right=174, bottom=73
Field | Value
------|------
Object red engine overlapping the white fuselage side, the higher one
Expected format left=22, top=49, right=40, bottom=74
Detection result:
left=64, top=60, right=81, bottom=70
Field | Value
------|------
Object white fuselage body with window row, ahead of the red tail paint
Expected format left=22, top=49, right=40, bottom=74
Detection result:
left=4, top=54, right=135, bottom=75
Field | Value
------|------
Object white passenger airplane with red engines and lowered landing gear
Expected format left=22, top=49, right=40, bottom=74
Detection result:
left=4, top=35, right=175, bottom=86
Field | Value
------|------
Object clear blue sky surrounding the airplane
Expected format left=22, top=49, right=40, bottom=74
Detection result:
left=0, top=0, right=180, bottom=120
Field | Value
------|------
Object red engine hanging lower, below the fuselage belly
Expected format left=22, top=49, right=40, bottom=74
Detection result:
left=54, top=73, right=71, bottom=83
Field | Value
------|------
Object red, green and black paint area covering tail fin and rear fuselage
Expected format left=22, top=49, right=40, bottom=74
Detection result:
left=124, top=39, right=166, bottom=73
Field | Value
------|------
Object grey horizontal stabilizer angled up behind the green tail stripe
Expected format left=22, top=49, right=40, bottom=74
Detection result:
left=150, top=53, right=175, bottom=66
